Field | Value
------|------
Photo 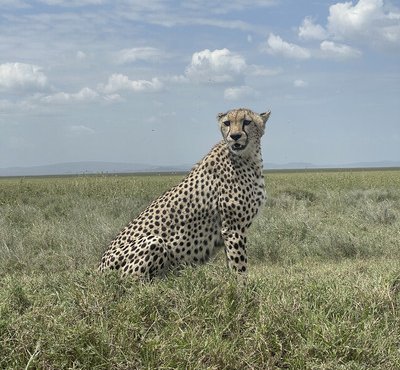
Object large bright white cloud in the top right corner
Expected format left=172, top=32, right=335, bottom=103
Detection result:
left=327, top=0, right=400, bottom=46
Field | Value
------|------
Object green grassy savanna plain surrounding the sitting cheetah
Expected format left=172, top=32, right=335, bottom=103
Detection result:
left=0, top=171, right=400, bottom=370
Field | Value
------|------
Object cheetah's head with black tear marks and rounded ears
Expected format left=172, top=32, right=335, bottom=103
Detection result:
left=217, top=108, right=271, bottom=155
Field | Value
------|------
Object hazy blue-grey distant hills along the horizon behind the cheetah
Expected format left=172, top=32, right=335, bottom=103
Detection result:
left=0, top=161, right=400, bottom=177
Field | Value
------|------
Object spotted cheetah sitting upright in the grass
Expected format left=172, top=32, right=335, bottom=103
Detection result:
left=99, top=108, right=271, bottom=280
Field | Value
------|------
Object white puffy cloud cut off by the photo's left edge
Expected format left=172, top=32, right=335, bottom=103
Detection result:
left=0, top=63, right=47, bottom=89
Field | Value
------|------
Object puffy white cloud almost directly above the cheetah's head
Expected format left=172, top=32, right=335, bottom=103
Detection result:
left=185, top=48, right=247, bottom=83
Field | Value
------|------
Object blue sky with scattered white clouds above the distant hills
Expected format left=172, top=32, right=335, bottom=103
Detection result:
left=0, top=0, right=400, bottom=168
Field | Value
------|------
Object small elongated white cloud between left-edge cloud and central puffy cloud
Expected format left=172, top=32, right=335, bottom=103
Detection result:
left=99, top=74, right=163, bottom=94
